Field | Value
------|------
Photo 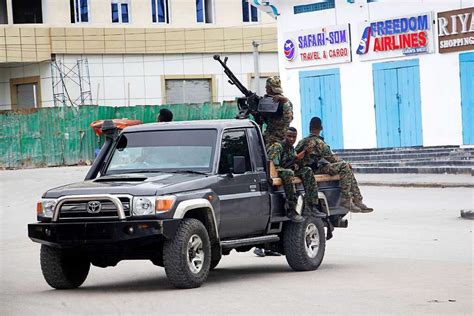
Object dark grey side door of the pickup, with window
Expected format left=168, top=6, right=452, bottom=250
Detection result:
left=215, top=129, right=269, bottom=238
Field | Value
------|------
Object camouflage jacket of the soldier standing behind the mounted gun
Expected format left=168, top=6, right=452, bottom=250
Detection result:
left=263, top=97, right=293, bottom=146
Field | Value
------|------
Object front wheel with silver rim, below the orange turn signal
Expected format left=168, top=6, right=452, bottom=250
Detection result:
left=163, top=218, right=211, bottom=289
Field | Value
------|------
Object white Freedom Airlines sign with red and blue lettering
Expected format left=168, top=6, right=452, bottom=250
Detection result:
left=356, top=13, right=434, bottom=60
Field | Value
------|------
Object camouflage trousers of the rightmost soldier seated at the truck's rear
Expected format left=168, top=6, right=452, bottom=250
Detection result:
left=318, top=161, right=362, bottom=201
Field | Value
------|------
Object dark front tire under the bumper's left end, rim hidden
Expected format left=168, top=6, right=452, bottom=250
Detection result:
left=40, top=245, right=90, bottom=290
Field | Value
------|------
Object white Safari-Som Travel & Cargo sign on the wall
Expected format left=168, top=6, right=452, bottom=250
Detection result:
left=282, top=24, right=352, bottom=68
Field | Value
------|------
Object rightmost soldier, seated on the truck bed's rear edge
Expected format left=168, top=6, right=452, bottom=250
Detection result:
left=296, top=117, right=373, bottom=213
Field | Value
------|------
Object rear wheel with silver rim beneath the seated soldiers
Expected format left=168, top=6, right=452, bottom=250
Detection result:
left=283, top=216, right=326, bottom=271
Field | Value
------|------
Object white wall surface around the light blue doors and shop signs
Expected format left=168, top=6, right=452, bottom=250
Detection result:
left=272, top=0, right=474, bottom=148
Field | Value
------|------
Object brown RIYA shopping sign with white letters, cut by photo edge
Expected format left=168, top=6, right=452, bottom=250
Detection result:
left=438, top=7, right=474, bottom=53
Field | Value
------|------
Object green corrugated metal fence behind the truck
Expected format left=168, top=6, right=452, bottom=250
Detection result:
left=0, top=102, right=237, bottom=168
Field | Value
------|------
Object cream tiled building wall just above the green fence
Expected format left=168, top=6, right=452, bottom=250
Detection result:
left=0, top=53, right=278, bottom=110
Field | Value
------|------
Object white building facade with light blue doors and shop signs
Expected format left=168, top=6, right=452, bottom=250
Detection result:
left=264, top=0, right=474, bottom=148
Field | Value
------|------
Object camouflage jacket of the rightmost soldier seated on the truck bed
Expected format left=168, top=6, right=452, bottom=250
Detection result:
left=296, top=134, right=341, bottom=166
